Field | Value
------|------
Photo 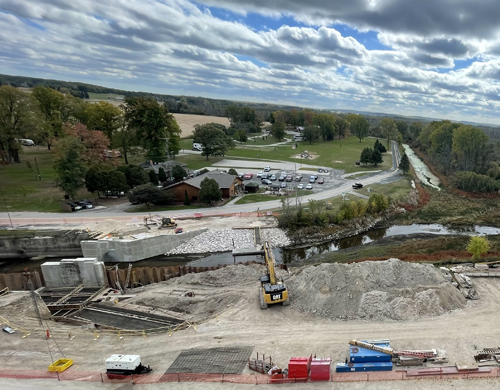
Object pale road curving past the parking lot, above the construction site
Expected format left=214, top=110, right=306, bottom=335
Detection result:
left=0, top=141, right=400, bottom=227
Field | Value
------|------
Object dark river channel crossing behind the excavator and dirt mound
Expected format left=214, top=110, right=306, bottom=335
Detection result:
left=0, top=224, right=500, bottom=273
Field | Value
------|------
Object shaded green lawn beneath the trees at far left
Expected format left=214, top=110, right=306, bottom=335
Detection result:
left=0, top=146, right=94, bottom=212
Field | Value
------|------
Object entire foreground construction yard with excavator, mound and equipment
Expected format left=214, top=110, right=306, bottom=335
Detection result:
left=0, top=241, right=500, bottom=389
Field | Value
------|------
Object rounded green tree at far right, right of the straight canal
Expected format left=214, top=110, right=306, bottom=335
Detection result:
left=453, top=125, right=488, bottom=173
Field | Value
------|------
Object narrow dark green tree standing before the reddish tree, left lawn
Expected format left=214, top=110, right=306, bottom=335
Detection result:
left=54, top=137, right=87, bottom=199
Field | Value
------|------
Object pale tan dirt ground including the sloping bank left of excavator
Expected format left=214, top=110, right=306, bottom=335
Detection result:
left=0, top=265, right=500, bottom=390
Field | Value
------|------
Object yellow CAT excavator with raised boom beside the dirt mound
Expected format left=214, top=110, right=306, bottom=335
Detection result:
left=259, top=241, right=290, bottom=310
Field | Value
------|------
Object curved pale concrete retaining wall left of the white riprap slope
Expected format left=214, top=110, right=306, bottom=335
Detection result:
left=81, top=228, right=208, bottom=263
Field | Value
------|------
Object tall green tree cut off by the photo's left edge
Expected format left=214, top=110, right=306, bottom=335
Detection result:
left=0, top=85, right=39, bottom=163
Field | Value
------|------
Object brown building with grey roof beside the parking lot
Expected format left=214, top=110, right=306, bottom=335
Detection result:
left=167, top=169, right=243, bottom=202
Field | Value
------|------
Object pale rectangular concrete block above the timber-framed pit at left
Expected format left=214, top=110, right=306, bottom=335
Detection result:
left=41, top=258, right=106, bottom=288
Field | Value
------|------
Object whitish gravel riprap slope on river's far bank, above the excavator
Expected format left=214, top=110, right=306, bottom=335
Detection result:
left=167, top=228, right=290, bottom=255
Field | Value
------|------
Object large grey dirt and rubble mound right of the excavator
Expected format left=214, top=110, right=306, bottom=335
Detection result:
left=287, top=259, right=465, bottom=321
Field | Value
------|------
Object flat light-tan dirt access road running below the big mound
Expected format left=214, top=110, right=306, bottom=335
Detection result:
left=0, top=272, right=500, bottom=390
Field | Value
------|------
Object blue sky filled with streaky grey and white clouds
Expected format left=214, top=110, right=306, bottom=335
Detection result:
left=0, top=0, right=500, bottom=125
